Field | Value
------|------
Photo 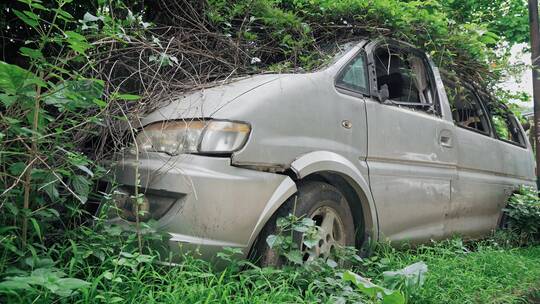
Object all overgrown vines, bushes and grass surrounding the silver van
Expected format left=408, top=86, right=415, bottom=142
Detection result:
left=0, top=0, right=540, bottom=303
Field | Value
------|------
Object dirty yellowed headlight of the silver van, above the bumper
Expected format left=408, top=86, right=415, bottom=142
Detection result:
left=131, top=120, right=251, bottom=155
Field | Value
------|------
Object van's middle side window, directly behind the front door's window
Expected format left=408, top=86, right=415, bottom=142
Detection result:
left=444, top=81, right=489, bottom=135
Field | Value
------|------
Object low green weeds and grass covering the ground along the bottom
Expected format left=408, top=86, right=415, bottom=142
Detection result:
left=0, top=215, right=540, bottom=303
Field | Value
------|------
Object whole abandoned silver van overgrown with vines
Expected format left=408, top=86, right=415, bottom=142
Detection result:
left=108, top=40, right=536, bottom=263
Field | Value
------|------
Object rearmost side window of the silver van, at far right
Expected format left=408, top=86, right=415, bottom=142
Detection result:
left=490, top=105, right=525, bottom=146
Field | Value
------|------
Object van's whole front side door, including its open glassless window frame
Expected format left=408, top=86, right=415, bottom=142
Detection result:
left=366, top=42, right=457, bottom=243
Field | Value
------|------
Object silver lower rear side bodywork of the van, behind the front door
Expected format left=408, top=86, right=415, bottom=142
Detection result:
left=456, top=135, right=535, bottom=237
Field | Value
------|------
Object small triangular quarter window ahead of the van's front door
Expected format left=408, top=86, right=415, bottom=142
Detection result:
left=336, top=53, right=368, bottom=93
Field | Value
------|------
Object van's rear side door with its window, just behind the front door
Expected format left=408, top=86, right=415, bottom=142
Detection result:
left=445, top=80, right=507, bottom=237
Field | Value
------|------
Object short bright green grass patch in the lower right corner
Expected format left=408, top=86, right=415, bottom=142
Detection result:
left=372, top=240, right=540, bottom=304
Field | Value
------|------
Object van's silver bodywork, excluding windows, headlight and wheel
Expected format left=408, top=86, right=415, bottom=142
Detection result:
left=109, top=41, right=534, bottom=258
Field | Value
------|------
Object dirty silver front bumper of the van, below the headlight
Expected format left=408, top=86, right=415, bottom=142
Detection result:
left=111, top=153, right=296, bottom=259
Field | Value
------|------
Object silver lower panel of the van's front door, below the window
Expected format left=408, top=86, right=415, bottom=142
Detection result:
left=366, top=101, right=456, bottom=243
